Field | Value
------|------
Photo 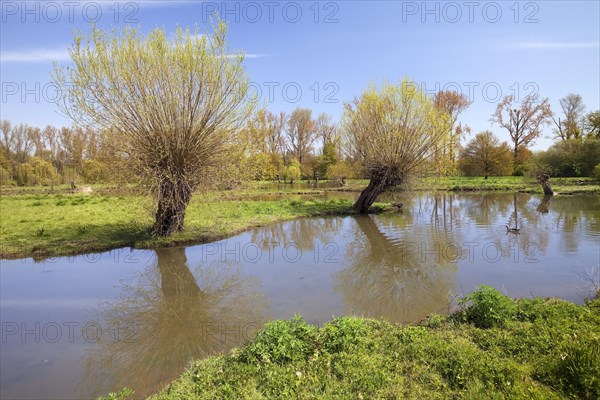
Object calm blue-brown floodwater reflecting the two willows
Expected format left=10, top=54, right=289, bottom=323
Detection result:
left=0, top=193, right=600, bottom=399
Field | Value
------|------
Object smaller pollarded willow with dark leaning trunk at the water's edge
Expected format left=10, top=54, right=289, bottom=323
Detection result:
left=342, top=79, right=451, bottom=214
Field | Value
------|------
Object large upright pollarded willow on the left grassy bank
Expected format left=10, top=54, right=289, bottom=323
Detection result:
left=53, top=21, right=254, bottom=236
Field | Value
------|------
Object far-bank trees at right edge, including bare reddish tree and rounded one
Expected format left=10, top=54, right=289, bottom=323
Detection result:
left=459, top=94, right=600, bottom=180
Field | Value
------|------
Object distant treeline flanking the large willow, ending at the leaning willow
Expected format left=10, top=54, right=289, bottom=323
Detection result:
left=0, top=108, right=359, bottom=186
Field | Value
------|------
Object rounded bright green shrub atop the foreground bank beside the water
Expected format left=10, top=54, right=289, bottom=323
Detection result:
left=460, top=285, right=514, bottom=329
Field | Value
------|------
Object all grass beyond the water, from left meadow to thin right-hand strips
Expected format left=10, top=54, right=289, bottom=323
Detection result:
left=0, top=178, right=600, bottom=260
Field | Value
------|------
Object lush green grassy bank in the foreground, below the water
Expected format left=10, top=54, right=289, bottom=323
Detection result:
left=127, top=287, right=600, bottom=400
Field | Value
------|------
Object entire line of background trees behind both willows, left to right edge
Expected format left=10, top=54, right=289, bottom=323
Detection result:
left=0, top=92, right=600, bottom=186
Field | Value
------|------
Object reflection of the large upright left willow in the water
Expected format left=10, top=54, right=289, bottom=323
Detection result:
left=80, top=248, right=269, bottom=397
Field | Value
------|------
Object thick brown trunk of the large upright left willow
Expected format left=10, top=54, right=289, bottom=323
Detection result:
left=154, top=180, right=192, bottom=236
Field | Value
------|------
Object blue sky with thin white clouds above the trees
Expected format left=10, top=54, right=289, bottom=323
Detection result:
left=0, top=1, right=600, bottom=149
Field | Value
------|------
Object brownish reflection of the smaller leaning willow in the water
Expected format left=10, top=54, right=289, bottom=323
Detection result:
left=336, top=216, right=457, bottom=322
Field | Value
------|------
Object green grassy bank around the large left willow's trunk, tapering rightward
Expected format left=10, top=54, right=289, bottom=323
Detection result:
left=0, top=193, right=352, bottom=258
